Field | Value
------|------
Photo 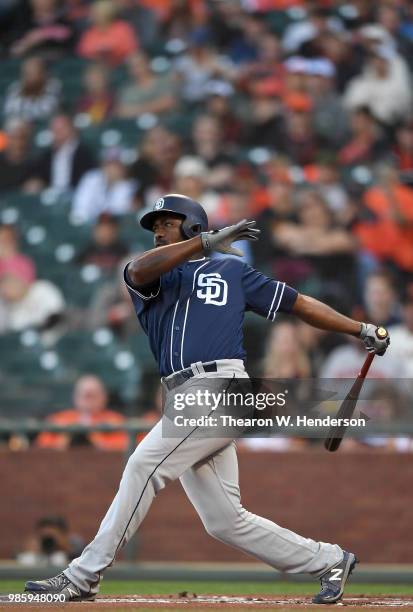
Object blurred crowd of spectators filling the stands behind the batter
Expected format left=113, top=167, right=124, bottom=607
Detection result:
left=0, top=0, right=413, bottom=448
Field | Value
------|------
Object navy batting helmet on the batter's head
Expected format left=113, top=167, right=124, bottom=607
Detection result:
left=140, top=193, right=208, bottom=238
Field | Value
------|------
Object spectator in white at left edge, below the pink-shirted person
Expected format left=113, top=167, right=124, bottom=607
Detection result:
left=0, top=266, right=65, bottom=333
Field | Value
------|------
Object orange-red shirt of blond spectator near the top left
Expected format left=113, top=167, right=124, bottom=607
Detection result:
left=77, top=20, right=139, bottom=66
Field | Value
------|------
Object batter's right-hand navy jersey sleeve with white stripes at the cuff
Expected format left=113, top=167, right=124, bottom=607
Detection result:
left=242, top=265, right=298, bottom=321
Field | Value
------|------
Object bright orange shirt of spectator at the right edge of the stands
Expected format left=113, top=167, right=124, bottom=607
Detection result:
left=355, top=185, right=413, bottom=272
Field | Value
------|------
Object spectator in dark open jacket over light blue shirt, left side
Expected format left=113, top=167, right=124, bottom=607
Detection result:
left=26, top=113, right=96, bottom=192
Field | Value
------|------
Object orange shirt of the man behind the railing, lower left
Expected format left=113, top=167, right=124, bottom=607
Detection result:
left=36, top=409, right=128, bottom=451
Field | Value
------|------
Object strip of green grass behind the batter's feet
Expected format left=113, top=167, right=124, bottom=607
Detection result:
left=0, top=580, right=413, bottom=596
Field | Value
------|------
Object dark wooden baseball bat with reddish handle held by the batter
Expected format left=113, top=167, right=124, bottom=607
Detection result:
left=324, top=327, right=388, bottom=453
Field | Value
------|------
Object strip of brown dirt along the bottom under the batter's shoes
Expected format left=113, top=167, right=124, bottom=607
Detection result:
left=0, top=592, right=413, bottom=612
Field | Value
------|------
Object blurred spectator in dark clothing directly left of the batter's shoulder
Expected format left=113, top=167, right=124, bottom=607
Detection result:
left=76, top=213, right=128, bottom=272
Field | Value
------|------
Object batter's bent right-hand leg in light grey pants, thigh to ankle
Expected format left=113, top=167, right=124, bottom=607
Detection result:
left=180, top=443, right=343, bottom=577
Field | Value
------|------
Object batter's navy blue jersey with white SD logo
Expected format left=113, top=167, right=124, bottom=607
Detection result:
left=125, top=257, right=298, bottom=376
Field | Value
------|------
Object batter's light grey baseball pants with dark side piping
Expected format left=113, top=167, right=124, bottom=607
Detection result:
left=65, top=360, right=343, bottom=592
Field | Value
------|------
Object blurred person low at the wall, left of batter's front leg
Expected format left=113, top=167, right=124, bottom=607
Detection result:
left=16, top=516, right=85, bottom=566
